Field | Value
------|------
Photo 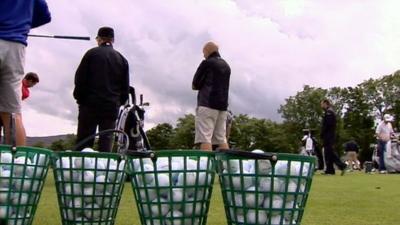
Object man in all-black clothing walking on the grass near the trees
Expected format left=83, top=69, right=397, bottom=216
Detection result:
left=321, top=99, right=346, bottom=176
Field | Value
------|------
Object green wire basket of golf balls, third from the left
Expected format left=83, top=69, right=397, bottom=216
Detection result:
left=128, top=150, right=215, bottom=225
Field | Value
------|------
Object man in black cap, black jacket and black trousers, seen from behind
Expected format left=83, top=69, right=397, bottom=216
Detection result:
left=74, top=27, right=129, bottom=151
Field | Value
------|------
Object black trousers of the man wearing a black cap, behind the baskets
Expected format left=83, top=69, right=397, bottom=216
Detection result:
left=76, top=105, right=118, bottom=152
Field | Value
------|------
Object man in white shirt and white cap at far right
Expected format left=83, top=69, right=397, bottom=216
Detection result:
left=375, top=114, right=394, bottom=174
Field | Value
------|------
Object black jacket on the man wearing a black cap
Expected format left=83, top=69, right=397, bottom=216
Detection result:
left=74, top=44, right=129, bottom=109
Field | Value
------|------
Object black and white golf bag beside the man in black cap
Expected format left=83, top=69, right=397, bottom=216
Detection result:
left=116, top=87, right=151, bottom=151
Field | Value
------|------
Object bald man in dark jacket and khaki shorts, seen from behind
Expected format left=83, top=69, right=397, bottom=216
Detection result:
left=192, top=42, right=231, bottom=151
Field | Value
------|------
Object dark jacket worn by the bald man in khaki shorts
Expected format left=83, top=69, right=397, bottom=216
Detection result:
left=192, top=52, right=231, bottom=111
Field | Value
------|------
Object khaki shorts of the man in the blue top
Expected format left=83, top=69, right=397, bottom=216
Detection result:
left=0, top=39, right=25, bottom=113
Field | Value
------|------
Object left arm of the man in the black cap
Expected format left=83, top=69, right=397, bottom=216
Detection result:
left=73, top=53, right=89, bottom=104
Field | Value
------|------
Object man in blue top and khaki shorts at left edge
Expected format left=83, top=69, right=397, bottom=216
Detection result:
left=0, top=0, right=51, bottom=145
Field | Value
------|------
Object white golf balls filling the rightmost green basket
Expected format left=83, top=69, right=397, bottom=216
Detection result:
left=222, top=150, right=310, bottom=224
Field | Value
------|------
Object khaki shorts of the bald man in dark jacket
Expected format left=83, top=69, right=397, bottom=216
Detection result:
left=194, top=106, right=227, bottom=145
